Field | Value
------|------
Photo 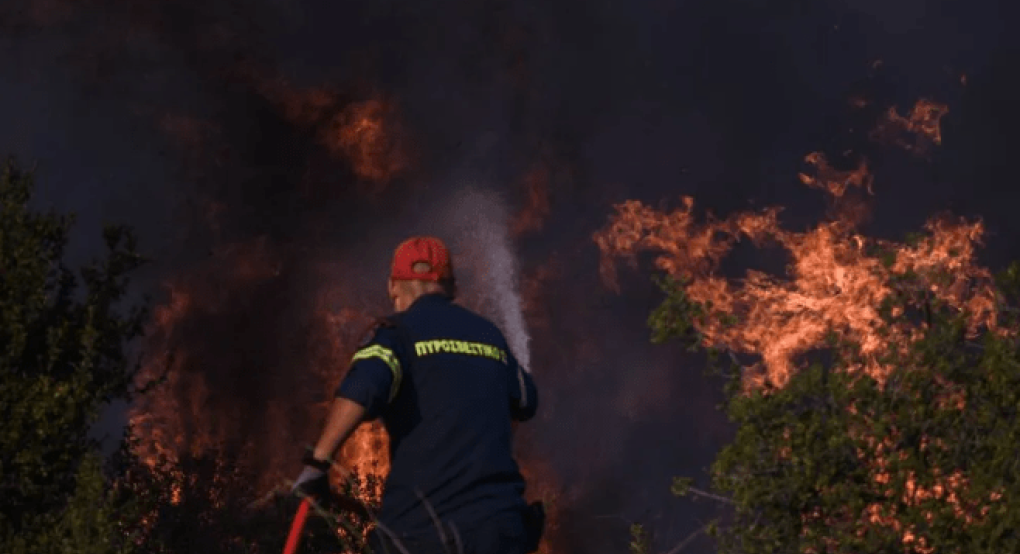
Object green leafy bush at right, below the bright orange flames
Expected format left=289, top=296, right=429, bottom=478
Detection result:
left=649, top=255, right=1020, bottom=554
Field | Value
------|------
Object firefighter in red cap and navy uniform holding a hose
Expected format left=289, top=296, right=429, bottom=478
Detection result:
left=294, top=237, right=542, bottom=554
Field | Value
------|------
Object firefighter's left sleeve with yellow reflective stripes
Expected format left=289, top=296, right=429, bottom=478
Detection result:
left=336, top=328, right=403, bottom=419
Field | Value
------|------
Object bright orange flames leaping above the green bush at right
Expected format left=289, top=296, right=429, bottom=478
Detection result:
left=594, top=96, right=1002, bottom=554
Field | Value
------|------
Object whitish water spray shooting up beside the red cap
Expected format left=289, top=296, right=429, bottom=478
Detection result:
left=437, top=188, right=531, bottom=371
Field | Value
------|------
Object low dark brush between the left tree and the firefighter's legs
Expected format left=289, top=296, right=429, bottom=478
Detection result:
left=108, top=440, right=377, bottom=554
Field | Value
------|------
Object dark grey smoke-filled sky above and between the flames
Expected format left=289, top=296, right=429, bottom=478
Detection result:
left=0, top=0, right=1020, bottom=552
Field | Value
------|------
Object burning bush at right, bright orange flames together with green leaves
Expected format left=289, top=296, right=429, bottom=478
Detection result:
left=594, top=101, right=1017, bottom=554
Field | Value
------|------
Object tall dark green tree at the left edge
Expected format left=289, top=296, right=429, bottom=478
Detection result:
left=0, top=160, right=145, bottom=554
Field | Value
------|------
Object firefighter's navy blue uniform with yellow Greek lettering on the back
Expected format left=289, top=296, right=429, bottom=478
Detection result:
left=337, top=294, right=538, bottom=552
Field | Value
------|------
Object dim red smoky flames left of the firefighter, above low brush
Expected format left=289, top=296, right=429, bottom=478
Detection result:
left=132, top=240, right=389, bottom=498
